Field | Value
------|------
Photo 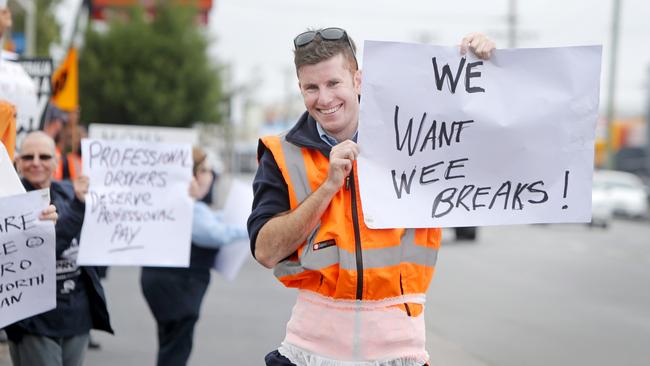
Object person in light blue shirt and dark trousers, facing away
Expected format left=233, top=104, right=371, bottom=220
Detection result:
left=140, top=147, right=246, bottom=366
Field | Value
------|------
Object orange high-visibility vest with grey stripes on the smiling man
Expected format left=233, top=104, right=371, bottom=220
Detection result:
left=262, top=136, right=441, bottom=304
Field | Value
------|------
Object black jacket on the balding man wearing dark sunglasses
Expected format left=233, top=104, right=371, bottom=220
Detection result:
left=6, top=180, right=113, bottom=342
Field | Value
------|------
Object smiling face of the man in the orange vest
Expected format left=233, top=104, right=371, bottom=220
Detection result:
left=298, top=54, right=361, bottom=142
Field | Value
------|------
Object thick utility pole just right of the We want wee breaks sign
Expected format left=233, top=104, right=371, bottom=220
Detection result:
left=605, top=0, right=621, bottom=169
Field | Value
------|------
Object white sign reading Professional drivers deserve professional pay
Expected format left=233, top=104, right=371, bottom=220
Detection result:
left=77, top=139, right=192, bottom=267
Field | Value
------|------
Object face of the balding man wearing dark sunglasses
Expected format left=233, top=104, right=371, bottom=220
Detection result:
left=16, top=131, right=56, bottom=189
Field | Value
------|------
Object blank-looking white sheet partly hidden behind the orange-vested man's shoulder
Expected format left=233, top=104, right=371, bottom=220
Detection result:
left=214, top=179, right=253, bottom=281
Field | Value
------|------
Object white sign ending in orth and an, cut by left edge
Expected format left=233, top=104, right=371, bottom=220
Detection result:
left=0, top=190, right=56, bottom=328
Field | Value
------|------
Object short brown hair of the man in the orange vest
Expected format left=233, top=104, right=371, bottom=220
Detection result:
left=293, top=29, right=359, bottom=73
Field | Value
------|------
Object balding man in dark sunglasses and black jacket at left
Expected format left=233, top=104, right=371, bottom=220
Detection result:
left=6, top=131, right=113, bottom=366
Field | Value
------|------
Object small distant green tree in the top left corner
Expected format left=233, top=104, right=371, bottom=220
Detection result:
left=9, top=0, right=61, bottom=57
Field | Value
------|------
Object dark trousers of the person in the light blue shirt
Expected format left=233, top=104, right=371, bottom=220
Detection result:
left=140, top=267, right=210, bottom=366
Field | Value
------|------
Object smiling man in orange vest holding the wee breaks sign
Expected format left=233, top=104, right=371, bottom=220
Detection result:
left=248, top=28, right=494, bottom=365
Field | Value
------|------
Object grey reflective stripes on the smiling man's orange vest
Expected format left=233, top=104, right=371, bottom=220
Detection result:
left=274, top=136, right=438, bottom=277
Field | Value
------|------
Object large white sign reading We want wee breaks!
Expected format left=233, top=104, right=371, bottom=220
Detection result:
left=358, top=42, right=601, bottom=228
